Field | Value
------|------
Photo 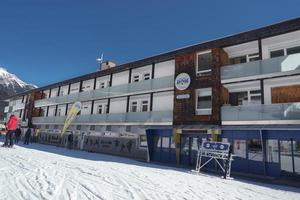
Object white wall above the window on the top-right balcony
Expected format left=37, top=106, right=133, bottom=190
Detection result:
left=262, top=30, right=300, bottom=59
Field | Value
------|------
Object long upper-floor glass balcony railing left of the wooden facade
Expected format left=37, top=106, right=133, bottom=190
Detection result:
left=34, top=76, right=174, bottom=107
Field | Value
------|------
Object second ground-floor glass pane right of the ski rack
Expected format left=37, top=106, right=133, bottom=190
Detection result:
left=248, top=139, right=263, bottom=161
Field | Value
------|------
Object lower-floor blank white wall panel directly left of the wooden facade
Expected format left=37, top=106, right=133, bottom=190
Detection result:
left=152, top=92, right=174, bottom=111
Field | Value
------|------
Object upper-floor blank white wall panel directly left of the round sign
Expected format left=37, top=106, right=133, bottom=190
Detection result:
left=154, top=60, right=175, bottom=78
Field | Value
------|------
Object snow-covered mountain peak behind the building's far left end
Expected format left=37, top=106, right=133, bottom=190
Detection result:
left=0, top=67, right=37, bottom=99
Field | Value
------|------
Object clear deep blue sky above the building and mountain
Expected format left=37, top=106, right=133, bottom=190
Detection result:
left=0, top=0, right=300, bottom=86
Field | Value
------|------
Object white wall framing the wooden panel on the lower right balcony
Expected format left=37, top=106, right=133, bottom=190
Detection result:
left=264, top=76, right=300, bottom=104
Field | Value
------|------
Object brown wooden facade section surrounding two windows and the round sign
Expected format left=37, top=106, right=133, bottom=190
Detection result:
left=173, top=48, right=228, bottom=125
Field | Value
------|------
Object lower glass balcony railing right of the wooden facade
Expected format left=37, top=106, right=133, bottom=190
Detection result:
left=222, top=103, right=300, bottom=125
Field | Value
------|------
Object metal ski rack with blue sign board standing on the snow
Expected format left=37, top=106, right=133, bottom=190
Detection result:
left=193, top=142, right=233, bottom=179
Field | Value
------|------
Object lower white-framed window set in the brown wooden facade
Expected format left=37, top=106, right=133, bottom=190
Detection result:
left=196, top=88, right=212, bottom=115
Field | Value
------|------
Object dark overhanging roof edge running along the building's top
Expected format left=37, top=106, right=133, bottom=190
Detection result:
left=6, top=17, right=300, bottom=99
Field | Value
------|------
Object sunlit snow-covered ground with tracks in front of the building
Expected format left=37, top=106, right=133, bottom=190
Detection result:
left=0, top=141, right=300, bottom=200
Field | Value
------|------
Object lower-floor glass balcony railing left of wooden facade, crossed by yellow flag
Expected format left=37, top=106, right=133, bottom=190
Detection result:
left=32, top=111, right=173, bottom=125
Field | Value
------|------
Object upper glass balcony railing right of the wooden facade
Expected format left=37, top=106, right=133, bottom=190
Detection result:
left=221, top=53, right=300, bottom=83
